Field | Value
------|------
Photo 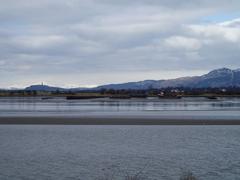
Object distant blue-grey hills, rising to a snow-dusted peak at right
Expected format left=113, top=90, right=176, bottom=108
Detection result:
left=25, top=68, right=240, bottom=91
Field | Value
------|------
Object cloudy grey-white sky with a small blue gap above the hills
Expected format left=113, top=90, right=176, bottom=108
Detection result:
left=0, top=0, right=240, bottom=88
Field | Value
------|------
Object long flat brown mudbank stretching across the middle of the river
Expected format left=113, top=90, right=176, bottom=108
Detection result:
left=0, top=116, right=240, bottom=125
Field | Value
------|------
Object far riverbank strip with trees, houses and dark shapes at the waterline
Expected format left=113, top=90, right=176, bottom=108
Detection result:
left=0, top=87, right=240, bottom=99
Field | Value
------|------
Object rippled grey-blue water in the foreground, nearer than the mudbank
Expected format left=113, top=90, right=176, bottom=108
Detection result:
left=0, top=125, right=240, bottom=180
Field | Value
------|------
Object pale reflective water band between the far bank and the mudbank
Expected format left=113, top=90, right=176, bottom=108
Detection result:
left=0, top=97, right=240, bottom=119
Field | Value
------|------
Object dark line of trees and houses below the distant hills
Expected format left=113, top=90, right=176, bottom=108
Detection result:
left=0, top=87, right=240, bottom=96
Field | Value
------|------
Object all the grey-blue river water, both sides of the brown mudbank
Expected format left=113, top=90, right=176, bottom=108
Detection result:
left=0, top=97, right=240, bottom=180
